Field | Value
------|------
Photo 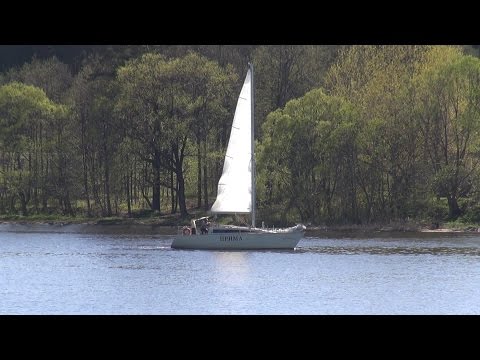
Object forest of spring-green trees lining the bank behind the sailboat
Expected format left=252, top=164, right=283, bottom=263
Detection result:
left=0, top=45, right=480, bottom=225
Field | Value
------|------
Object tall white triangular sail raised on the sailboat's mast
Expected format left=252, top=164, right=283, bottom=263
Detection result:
left=211, top=69, right=252, bottom=213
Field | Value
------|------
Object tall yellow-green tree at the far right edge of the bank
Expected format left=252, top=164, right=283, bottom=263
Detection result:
left=416, top=47, right=480, bottom=219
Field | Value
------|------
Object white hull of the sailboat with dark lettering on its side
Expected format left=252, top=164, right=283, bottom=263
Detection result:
left=171, top=227, right=304, bottom=250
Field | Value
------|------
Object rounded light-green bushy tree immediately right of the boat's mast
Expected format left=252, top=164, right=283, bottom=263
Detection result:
left=258, top=89, right=356, bottom=222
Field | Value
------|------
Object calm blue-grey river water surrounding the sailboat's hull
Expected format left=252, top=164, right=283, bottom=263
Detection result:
left=0, top=224, right=480, bottom=314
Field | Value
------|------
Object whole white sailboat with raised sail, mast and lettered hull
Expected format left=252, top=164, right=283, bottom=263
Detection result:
left=171, top=63, right=305, bottom=250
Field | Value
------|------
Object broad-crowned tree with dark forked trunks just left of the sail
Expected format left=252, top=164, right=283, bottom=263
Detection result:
left=117, top=53, right=234, bottom=216
